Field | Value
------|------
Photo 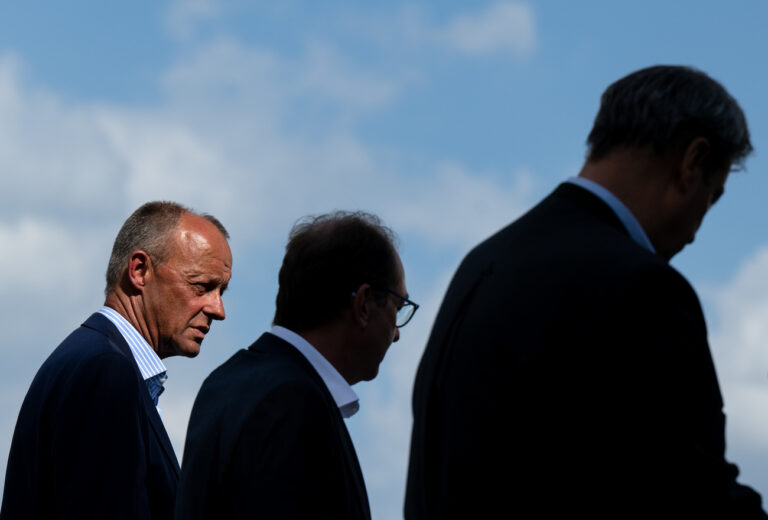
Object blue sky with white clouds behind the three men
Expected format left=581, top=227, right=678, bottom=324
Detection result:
left=0, top=0, right=768, bottom=519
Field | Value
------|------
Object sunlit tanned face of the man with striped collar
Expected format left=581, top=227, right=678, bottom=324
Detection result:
left=143, top=213, right=232, bottom=358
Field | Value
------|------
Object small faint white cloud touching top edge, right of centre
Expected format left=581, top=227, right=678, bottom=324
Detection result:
left=439, top=2, right=536, bottom=57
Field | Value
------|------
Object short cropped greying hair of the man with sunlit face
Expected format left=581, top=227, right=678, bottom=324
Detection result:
left=104, top=201, right=229, bottom=294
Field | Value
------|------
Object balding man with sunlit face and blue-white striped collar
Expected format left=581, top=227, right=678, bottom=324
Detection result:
left=0, top=202, right=232, bottom=520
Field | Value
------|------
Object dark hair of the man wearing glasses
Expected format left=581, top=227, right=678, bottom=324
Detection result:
left=274, top=211, right=401, bottom=331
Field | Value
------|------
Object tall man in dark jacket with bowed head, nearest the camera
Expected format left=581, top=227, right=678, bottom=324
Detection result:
left=405, top=66, right=766, bottom=520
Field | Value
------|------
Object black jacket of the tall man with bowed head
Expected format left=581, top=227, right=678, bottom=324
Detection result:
left=405, top=184, right=765, bottom=520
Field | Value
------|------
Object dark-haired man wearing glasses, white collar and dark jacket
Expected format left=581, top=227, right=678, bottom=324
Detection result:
left=176, top=212, right=418, bottom=519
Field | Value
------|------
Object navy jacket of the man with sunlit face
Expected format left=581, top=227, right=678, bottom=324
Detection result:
left=0, top=313, right=179, bottom=520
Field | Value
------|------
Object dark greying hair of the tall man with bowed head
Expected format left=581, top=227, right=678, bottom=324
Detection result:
left=587, top=65, right=752, bottom=171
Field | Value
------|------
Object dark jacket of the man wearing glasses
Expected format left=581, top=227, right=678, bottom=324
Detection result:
left=176, top=333, right=370, bottom=520
